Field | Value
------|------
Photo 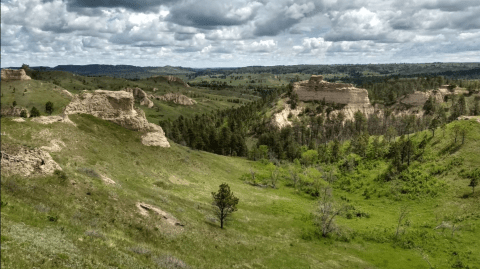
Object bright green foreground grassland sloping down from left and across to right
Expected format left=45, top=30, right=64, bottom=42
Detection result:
left=1, top=110, right=480, bottom=268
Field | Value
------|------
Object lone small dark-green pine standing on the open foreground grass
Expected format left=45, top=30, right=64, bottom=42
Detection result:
left=212, top=183, right=239, bottom=229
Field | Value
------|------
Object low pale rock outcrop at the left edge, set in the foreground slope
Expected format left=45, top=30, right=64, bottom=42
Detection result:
left=1, top=145, right=62, bottom=177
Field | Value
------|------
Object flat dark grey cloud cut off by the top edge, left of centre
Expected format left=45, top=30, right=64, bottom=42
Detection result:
left=67, top=0, right=176, bottom=12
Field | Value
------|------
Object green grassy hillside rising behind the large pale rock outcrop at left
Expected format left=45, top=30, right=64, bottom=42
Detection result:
left=1, top=71, right=259, bottom=121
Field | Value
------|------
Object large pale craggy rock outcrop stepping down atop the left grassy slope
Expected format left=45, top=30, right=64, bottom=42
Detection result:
left=65, top=90, right=170, bottom=147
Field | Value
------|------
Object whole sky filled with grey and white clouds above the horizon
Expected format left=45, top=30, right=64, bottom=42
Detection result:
left=1, top=0, right=480, bottom=67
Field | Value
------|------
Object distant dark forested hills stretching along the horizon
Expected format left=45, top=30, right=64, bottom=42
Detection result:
left=4, top=63, right=480, bottom=80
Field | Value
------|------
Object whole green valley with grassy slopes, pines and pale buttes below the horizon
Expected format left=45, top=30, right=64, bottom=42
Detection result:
left=1, top=65, right=480, bottom=268
